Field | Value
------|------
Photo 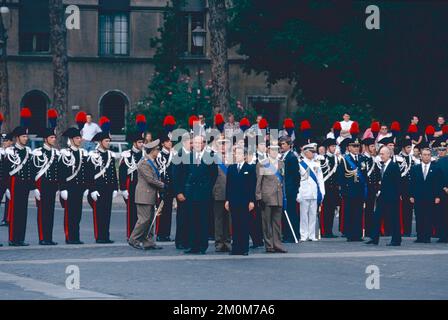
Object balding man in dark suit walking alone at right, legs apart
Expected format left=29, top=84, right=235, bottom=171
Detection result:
left=367, top=146, right=401, bottom=246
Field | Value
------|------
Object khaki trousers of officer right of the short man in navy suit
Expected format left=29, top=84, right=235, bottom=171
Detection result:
left=261, top=206, right=283, bottom=250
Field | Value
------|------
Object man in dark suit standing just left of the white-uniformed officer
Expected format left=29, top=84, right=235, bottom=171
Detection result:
left=279, top=136, right=300, bottom=243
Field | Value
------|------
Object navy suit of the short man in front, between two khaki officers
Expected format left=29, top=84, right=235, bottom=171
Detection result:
left=226, top=163, right=257, bottom=254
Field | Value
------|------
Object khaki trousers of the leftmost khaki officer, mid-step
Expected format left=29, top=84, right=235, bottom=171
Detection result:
left=129, top=204, right=156, bottom=248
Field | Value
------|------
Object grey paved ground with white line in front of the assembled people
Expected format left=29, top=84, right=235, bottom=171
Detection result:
left=0, top=202, right=448, bottom=300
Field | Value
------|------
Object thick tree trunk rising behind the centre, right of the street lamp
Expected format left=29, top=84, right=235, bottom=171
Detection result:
left=208, top=0, right=230, bottom=114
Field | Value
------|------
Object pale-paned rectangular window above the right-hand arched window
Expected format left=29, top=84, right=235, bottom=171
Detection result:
left=100, top=13, right=129, bottom=56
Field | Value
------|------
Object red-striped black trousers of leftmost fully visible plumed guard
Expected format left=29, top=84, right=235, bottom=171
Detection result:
left=8, top=176, right=32, bottom=242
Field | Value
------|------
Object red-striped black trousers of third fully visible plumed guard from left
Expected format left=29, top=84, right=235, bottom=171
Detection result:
left=60, top=184, right=86, bottom=241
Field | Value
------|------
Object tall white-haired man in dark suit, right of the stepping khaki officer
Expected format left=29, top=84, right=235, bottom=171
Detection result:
left=185, top=136, right=218, bottom=254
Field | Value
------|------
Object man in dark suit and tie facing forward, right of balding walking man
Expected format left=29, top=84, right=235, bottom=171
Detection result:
left=410, top=148, right=443, bottom=243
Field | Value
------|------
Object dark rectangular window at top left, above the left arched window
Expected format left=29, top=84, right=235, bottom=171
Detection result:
left=19, top=0, right=50, bottom=53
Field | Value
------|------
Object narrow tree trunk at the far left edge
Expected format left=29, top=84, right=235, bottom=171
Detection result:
left=0, top=18, right=12, bottom=132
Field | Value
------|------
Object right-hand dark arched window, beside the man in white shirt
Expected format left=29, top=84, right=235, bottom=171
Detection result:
left=100, top=91, right=129, bottom=134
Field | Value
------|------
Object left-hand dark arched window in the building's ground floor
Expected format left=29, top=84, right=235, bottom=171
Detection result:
left=20, top=90, right=50, bottom=134
